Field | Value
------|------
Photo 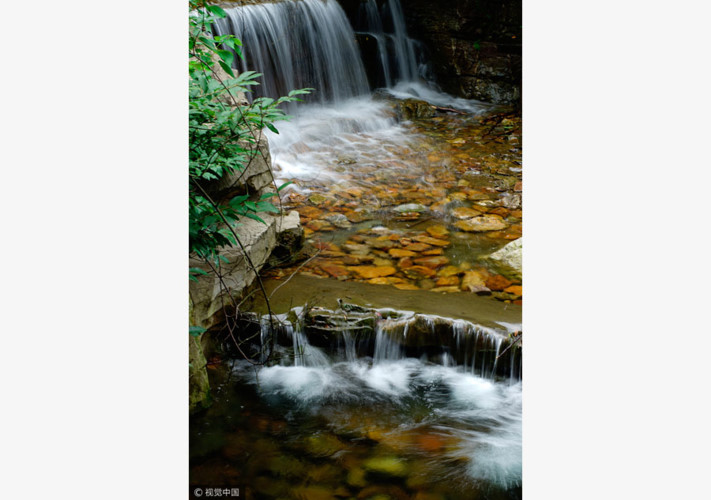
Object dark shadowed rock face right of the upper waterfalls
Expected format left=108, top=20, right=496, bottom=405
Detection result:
left=401, top=0, right=522, bottom=104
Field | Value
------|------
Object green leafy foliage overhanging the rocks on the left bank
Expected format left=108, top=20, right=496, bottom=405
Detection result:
left=189, top=0, right=310, bottom=279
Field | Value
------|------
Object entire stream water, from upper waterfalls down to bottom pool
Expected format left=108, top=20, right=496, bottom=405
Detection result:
left=195, top=0, right=522, bottom=500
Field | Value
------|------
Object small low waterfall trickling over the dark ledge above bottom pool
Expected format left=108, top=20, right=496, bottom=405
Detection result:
left=253, top=308, right=522, bottom=383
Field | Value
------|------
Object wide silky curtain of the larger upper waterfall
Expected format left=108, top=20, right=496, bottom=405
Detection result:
left=215, top=0, right=369, bottom=103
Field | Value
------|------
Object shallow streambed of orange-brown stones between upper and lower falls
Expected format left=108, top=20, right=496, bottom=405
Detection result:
left=267, top=100, right=523, bottom=305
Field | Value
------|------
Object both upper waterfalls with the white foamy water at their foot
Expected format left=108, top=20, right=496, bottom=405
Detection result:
left=215, top=0, right=486, bottom=191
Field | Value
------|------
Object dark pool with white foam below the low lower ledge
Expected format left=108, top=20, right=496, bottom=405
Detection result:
left=191, top=358, right=521, bottom=499
